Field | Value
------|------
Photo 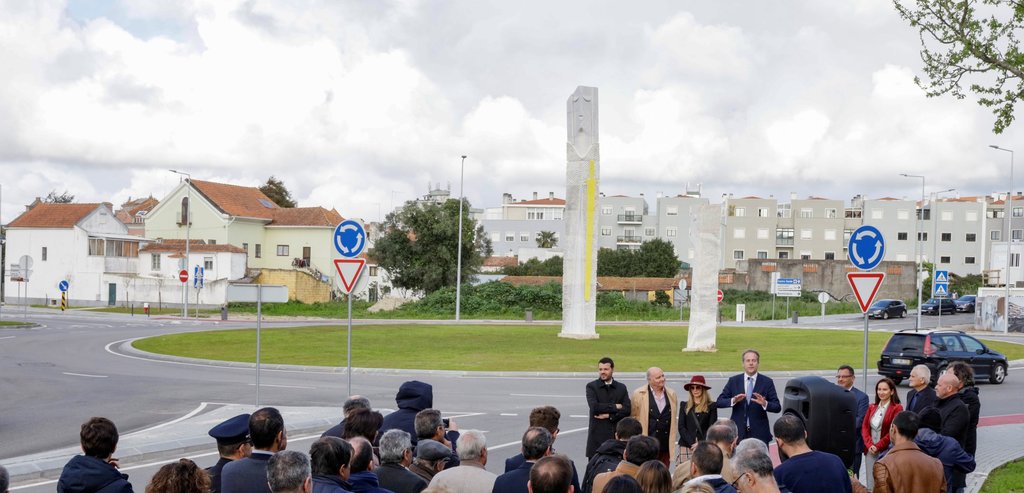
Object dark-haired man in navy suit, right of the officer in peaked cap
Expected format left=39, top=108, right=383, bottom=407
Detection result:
left=220, top=407, right=288, bottom=493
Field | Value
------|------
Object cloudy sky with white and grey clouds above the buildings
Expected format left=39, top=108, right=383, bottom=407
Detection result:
left=0, top=0, right=1024, bottom=221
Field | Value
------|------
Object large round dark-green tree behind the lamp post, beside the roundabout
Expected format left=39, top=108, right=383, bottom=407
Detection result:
left=370, top=199, right=492, bottom=293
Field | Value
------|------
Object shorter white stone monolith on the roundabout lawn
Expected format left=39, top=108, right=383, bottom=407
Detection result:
left=683, top=205, right=722, bottom=351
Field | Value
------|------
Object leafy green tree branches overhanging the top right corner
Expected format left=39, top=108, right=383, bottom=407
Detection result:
left=895, top=0, right=1024, bottom=133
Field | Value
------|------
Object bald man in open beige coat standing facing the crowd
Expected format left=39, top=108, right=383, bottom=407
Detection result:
left=630, top=367, right=679, bottom=467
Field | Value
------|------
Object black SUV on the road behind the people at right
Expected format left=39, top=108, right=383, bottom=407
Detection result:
left=879, top=329, right=1007, bottom=383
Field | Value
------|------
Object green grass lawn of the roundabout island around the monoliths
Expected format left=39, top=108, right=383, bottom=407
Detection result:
left=134, top=325, right=1024, bottom=371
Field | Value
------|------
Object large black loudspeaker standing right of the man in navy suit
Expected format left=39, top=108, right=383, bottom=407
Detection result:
left=782, top=376, right=860, bottom=468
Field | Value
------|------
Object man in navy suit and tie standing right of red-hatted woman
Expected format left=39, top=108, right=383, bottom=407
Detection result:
left=716, top=350, right=782, bottom=444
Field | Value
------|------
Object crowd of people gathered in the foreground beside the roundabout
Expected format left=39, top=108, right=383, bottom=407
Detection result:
left=6, top=350, right=980, bottom=493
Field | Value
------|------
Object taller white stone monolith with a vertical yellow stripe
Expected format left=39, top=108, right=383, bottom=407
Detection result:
left=558, top=86, right=601, bottom=339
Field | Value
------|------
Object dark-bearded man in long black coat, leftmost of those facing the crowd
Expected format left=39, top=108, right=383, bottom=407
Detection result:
left=587, top=357, right=630, bottom=460
